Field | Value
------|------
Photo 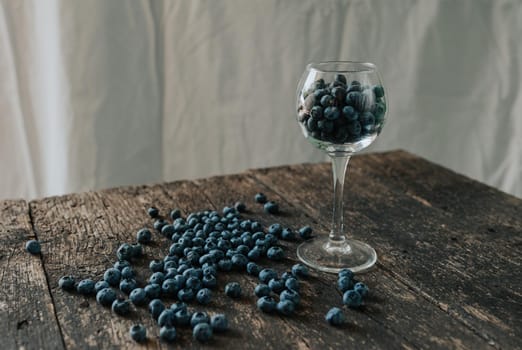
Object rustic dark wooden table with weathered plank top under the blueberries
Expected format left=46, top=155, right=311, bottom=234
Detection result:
left=0, top=151, right=522, bottom=349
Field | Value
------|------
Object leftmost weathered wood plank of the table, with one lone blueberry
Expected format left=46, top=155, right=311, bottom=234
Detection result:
left=0, top=200, right=64, bottom=349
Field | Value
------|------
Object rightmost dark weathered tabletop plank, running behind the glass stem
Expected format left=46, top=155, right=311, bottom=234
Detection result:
left=249, top=153, right=522, bottom=347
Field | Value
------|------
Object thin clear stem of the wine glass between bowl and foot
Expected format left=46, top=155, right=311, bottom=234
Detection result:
left=329, top=153, right=350, bottom=244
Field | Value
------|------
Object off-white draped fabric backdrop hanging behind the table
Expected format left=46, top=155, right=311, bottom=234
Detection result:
left=0, top=0, right=522, bottom=198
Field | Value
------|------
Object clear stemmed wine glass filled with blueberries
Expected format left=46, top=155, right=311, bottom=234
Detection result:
left=297, top=61, right=387, bottom=273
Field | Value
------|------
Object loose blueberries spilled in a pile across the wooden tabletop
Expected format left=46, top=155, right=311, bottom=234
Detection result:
left=53, top=197, right=324, bottom=342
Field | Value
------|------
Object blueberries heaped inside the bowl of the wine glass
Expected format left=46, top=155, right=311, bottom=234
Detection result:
left=297, top=74, right=386, bottom=144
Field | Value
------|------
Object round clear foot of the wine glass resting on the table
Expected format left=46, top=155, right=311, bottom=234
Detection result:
left=297, top=236, right=377, bottom=273
